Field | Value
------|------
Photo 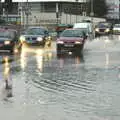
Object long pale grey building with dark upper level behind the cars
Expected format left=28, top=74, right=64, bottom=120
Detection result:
left=2, top=0, right=86, bottom=24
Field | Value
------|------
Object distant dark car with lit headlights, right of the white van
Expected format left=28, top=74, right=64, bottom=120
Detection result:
left=95, top=22, right=113, bottom=37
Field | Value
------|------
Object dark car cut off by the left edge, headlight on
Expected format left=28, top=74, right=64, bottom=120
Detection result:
left=0, top=28, right=18, bottom=53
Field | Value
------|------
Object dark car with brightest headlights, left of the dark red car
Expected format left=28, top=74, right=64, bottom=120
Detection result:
left=19, top=27, right=52, bottom=47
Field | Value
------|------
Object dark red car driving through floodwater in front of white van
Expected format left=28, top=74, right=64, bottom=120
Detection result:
left=56, top=29, right=87, bottom=56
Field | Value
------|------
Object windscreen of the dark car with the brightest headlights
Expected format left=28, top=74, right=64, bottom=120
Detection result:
left=25, top=28, right=45, bottom=35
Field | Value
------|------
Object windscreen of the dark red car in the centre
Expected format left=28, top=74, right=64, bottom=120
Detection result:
left=60, top=30, right=83, bottom=37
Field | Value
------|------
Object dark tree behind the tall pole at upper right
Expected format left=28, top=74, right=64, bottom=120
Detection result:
left=87, top=0, right=108, bottom=17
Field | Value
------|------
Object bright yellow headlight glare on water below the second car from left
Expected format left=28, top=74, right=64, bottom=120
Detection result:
left=20, top=46, right=53, bottom=72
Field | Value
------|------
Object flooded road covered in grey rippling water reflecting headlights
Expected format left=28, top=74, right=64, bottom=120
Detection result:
left=0, top=36, right=120, bottom=120
